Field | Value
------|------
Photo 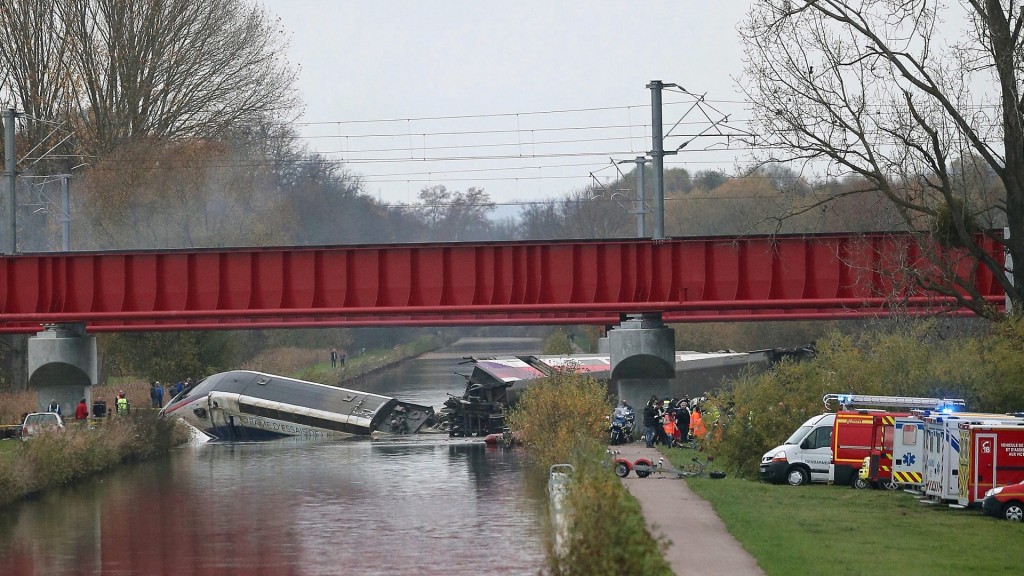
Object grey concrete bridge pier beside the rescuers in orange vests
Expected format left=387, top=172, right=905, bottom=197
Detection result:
left=599, top=313, right=676, bottom=409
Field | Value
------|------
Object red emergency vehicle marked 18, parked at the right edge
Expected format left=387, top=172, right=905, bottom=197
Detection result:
left=957, top=418, right=1024, bottom=506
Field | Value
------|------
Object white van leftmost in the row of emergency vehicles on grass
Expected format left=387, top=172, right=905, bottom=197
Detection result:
left=761, top=413, right=836, bottom=486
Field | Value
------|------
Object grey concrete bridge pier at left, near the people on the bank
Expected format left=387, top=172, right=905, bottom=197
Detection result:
left=28, top=324, right=98, bottom=412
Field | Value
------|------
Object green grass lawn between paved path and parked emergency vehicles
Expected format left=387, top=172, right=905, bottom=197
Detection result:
left=669, top=450, right=1024, bottom=576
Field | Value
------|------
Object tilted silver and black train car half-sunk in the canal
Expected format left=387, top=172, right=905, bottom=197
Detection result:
left=161, top=370, right=434, bottom=442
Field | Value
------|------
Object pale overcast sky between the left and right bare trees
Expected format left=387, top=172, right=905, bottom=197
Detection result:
left=264, top=0, right=751, bottom=206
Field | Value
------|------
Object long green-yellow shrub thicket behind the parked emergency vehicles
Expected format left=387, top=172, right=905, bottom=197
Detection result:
left=705, top=318, right=1024, bottom=478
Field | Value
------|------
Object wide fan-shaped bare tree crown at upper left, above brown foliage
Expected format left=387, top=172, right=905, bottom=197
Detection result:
left=61, top=0, right=297, bottom=152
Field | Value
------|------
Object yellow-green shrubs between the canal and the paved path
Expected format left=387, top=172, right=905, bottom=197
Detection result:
left=508, top=371, right=672, bottom=576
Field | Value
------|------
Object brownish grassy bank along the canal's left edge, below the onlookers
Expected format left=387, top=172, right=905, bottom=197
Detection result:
left=0, top=410, right=188, bottom=506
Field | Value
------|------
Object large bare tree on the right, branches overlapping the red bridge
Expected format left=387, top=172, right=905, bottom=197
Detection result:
left=740, top=0, right=1024, bottom=318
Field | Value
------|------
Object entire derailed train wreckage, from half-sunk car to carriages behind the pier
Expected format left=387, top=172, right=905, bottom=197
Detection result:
left=161, top=351, right=778, bottom=441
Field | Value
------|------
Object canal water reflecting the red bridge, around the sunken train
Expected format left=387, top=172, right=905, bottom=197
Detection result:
left=0, top=339, right=547, bottom=576
